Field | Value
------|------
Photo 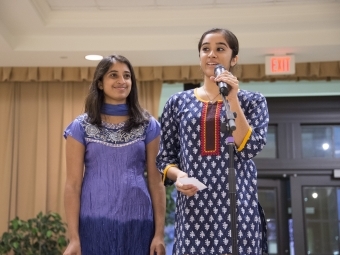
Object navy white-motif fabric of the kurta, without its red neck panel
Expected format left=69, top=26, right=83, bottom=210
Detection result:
left=157, top=90, right=269, bottom=255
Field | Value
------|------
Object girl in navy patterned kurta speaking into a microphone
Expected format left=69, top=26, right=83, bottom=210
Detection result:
left=157, top=29, right=269, bottom=255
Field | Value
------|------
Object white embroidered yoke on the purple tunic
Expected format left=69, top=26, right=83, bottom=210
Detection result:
left=77, top=114, right=146, bottom=147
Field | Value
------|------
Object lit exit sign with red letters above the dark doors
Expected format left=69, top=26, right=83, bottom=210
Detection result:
left=266, top=55, right=295, bottom=75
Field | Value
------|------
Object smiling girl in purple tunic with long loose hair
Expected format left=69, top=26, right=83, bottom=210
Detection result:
left=64, top=55, right=165, bottom=255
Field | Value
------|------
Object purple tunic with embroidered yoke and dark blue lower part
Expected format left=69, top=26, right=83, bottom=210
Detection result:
left=64, top=114, right=160, bottom=255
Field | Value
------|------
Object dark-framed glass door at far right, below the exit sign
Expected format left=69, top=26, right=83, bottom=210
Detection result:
left=290, top=176, right=340, bottom=255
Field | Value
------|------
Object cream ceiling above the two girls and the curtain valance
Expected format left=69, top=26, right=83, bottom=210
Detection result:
left=0, top=0, right=340, bottom=67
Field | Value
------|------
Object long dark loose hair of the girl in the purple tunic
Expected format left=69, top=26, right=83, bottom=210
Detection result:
left=85, top=55, right=150, bottom=132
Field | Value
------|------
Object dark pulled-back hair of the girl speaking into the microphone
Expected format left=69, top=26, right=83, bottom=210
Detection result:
left=198, top=28, right=239, bottom=70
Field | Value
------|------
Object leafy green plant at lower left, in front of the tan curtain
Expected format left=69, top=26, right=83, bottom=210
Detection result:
left=0, top=212, right=67, bottom=255
